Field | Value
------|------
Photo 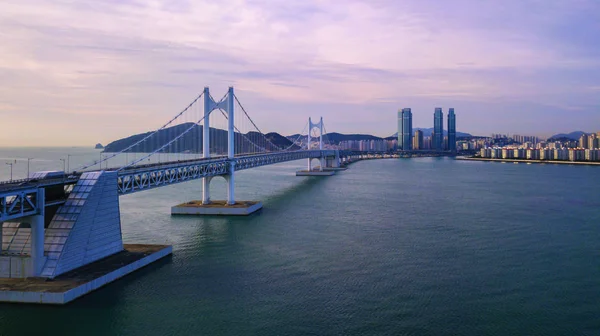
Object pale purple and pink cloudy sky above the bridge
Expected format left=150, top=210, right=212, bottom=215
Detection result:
left=0, top=0, right=600, bottom=146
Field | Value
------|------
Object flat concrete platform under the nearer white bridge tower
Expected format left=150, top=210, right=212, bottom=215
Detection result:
left=171, top=200, right=262, bottom=216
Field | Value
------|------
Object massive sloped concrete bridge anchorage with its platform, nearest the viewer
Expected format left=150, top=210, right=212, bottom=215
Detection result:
left=0, top=171, right=171, bottom=304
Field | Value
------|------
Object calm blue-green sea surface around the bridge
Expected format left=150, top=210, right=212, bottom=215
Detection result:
left=0, top=148, right=600, bottom=335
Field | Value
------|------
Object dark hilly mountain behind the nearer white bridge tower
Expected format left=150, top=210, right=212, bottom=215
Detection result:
left=104, top=123, right=300, bottom=154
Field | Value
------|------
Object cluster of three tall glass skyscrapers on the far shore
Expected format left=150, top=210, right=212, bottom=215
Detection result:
left=398, top=107, right=456, bottom=151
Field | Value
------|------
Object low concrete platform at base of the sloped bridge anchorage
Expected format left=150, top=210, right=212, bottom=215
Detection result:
left=0, top=244, right=173, bottom=305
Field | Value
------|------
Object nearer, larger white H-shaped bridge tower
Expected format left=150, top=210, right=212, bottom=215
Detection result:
left=202, top=86, right=235, bottom=205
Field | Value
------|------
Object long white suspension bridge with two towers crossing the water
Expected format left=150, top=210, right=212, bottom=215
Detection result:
left=0, top=87, right=380, bottom=292
